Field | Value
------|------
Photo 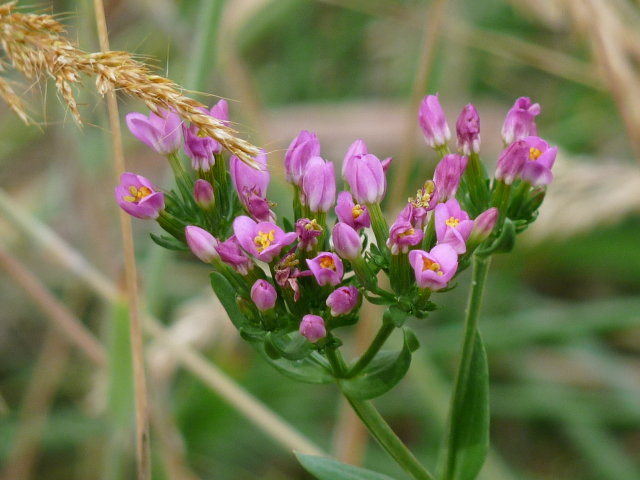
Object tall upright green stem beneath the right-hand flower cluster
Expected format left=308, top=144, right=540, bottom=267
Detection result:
left=442, top=255, right=491, bottom=480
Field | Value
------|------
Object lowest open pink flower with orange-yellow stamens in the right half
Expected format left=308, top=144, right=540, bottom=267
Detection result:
left=409, top=243, right=458, bottom=291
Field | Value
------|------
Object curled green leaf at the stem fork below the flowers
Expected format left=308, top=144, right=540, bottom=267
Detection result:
left=340, top=329, right=417, bottom=400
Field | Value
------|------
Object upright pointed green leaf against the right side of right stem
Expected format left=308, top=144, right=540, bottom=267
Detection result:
left=445, top=330, right=489, bottom=480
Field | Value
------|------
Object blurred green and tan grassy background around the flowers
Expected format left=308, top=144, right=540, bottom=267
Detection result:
left=0, top=0, right=640, bottom=480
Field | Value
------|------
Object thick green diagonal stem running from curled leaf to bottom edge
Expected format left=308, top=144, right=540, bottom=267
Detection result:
left=343, top=392, right=435, bottom=480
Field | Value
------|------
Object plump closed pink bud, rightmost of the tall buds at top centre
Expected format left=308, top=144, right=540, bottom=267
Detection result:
left=344, top=154, right=387, bottom=203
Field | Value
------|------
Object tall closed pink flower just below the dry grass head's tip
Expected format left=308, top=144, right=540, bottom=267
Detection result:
left=229, top=151, right=275, bottom=222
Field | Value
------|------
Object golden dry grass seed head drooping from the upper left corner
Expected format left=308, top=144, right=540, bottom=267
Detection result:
left=0, top=2, right=259, bottom=167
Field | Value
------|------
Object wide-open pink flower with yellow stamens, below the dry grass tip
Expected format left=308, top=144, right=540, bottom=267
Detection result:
left=233, top=215, right=298, bottom=263
